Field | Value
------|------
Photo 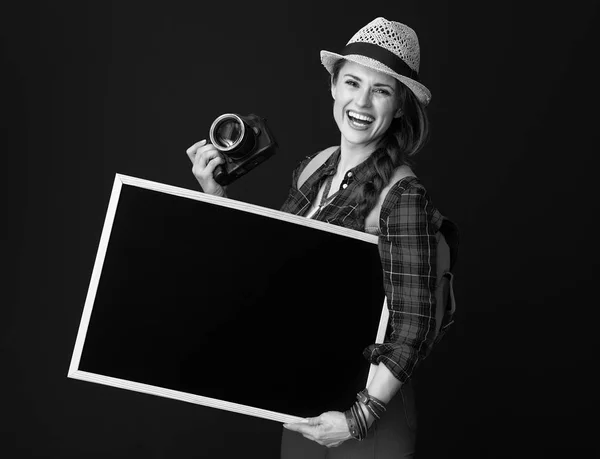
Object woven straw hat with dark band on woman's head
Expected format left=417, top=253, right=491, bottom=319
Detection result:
left=321, top=17, right=431, bottom=105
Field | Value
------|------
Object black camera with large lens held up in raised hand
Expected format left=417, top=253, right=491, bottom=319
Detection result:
left=209, top=113, right=277, bottom=186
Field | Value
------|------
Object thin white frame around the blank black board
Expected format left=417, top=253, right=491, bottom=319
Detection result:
left=67, top=174, right=389, bottom=423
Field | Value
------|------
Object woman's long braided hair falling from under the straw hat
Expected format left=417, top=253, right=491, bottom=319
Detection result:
left=332, top=59, right=429, bottom=221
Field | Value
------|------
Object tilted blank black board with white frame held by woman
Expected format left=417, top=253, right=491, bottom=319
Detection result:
left=68, top=174, right=387, bottom=422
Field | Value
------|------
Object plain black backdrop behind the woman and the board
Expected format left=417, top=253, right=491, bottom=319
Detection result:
left=0, top=0, right=598, bottom=458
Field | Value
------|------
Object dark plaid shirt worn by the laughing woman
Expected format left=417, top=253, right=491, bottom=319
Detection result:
left=281, top=148, right=457, bottom=383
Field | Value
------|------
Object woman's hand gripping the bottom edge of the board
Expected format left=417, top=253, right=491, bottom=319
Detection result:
left=283, top=411, right=352, bottom=448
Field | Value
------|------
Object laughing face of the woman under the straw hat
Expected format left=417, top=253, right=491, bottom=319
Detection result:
left=331, top=61, right=402, bottom=151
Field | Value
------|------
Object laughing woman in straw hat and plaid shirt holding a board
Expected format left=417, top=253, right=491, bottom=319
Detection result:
left=187, top=18, right=456, bottom=458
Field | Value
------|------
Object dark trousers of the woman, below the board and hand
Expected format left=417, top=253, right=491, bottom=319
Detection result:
left=281, top=382, right=417, bottom=459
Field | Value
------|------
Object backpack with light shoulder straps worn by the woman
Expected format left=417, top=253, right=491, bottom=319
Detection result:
left=297, top=146, right=456, bottom=341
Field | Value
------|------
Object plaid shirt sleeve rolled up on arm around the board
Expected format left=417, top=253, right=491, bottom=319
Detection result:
left=364, top=186, right=437, bottom=383
